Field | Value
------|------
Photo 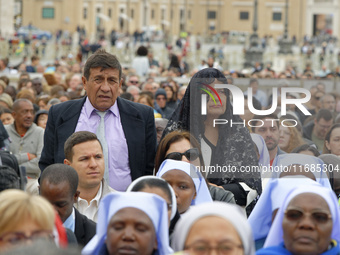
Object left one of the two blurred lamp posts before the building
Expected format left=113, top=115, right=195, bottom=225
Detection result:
left=244, top=0, right=263, bottom=67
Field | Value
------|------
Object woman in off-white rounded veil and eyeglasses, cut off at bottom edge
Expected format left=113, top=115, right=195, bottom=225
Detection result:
left=171, top=201, right=255, bottom=255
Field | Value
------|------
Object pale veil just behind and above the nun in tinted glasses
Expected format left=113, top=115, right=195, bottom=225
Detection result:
left=272, top=153, right=331, bottom=188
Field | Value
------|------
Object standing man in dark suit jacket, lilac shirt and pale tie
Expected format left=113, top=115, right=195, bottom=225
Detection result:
left=39, top=50, right=156, bottom=191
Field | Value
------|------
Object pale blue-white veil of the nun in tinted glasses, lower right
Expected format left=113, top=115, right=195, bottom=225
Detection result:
left=264, top=186, right=340, bottom=248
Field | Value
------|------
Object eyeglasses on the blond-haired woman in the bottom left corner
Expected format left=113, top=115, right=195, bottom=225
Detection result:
left=0, top=230, right=54, bottom=245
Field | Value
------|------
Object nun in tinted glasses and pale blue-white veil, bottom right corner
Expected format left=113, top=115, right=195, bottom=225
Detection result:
left=256, top=186, right=340, bottom=255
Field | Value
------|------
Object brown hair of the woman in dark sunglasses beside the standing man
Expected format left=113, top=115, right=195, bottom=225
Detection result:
left=155, top=131, right=204, bottom=174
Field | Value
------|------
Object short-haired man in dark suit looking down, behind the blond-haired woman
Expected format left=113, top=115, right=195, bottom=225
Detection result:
left=39, top=164, right=96, bottom=246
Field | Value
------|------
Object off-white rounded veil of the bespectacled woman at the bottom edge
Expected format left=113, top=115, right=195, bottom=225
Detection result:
left=171, top=201, right=255, bottom=255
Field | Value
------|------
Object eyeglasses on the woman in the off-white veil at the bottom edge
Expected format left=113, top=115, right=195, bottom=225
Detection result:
left=185, top=241, right=243, bottom=255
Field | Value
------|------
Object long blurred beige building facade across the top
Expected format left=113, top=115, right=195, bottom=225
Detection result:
left=7, top=0, right=340, bottom=40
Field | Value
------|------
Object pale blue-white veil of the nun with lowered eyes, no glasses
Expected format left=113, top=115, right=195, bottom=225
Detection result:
left=82, top=192, right=173, bottom=255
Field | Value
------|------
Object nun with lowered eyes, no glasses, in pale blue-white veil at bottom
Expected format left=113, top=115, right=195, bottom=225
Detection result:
left=82, top=192, right=173, bottom=255
